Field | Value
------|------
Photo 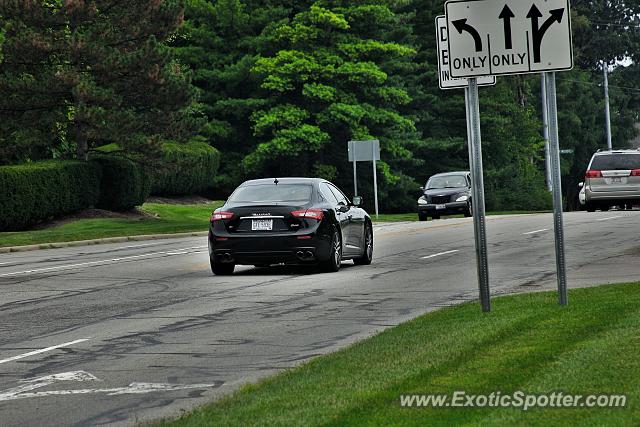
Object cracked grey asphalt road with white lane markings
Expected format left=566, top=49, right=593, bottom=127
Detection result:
left=0, top=211, right=640, bottom=426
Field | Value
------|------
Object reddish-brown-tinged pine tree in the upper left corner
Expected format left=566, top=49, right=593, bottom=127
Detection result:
left=0, top=0, right=194, bottom=159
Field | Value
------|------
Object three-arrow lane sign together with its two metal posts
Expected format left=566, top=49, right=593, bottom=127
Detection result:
left=445, top=0, right=573, bottom=311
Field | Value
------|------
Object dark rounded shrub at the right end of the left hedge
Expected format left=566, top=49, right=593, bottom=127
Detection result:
left=91, top=155, right=151, bottom=211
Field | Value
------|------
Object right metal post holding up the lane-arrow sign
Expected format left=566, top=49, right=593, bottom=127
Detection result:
left=546, top=73, right=569, bottom=305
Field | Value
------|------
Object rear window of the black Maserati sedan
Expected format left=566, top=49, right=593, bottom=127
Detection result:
left=229, top=184, right=312, bottom=204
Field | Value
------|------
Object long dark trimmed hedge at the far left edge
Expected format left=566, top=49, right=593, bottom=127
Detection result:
left=0, top=161, right=101, bottom=231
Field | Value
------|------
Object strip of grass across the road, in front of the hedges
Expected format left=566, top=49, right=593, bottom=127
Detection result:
left=0, top=202, right=222, bottom=247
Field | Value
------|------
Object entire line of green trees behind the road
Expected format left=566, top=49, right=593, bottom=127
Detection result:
left=0, top=0, right=640, bottom=212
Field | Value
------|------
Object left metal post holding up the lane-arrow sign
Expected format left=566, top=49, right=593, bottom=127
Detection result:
left=466, top=78, right=491, bottom=313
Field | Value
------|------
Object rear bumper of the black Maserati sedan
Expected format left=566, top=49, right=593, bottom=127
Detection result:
left=209, top=232, right=331, bottom=265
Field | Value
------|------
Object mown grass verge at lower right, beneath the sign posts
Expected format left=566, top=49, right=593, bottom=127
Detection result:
left=162, top=283, right=640, bottom=427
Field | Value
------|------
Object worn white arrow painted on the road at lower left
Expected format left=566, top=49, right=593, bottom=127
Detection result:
left=0, top=371, right=220, bottom=402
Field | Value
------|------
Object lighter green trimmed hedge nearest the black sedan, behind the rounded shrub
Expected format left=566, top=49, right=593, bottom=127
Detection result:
left=151, top=141, right=220, bottom=196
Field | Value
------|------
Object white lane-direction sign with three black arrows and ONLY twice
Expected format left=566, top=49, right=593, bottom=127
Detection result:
left=445, top=0, right=573, bottom=78
